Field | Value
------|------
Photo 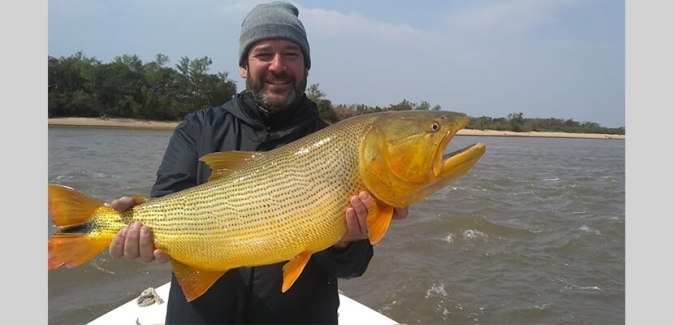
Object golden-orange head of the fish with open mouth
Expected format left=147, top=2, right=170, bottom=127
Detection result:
left=359, top=111, right=485, bottom=207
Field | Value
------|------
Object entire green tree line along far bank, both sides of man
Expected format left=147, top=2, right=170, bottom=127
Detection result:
left=47, top=52, right=625, bottom=135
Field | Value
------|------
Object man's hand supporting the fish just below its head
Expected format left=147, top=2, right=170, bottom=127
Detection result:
left=333, top=192, right=409, bottom=249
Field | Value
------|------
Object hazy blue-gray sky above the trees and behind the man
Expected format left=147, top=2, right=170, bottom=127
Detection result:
left=48, top=0, right=625, bottom=127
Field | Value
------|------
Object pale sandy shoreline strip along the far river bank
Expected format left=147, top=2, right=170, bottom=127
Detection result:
left=48, top=117, right=625, bottom=140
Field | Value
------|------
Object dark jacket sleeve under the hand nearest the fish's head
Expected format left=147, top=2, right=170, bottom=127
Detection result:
left=313, top=239, right=374, bottom=279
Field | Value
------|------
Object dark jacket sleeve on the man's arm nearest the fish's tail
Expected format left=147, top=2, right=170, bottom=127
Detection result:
left=150, top=115, right=199, bottom=197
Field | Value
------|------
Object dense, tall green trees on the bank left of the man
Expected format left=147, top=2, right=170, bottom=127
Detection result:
left=47, top=52, right=236, bottom=121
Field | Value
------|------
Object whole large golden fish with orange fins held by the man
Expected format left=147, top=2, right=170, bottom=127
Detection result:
left=48, top=111, right=485, bottom=301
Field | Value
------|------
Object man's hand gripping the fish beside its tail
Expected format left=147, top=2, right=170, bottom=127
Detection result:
left=108, top=196, right=171, bottom=263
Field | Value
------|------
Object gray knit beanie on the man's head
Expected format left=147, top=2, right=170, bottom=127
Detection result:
left=239, top=2, right=311, bottom=68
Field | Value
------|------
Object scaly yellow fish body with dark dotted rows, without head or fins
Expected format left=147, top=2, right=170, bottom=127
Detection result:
left=117, top=114, right=370, bottom=270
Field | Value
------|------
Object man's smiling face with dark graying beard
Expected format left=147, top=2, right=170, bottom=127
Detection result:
left=241, top=39, right=309, bottom=112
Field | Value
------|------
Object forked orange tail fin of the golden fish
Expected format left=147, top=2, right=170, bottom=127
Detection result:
left=48, top=184, right=110, bottom=270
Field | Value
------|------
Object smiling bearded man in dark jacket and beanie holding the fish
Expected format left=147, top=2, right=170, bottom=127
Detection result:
left=109, top=2, right=407, bottom=324
